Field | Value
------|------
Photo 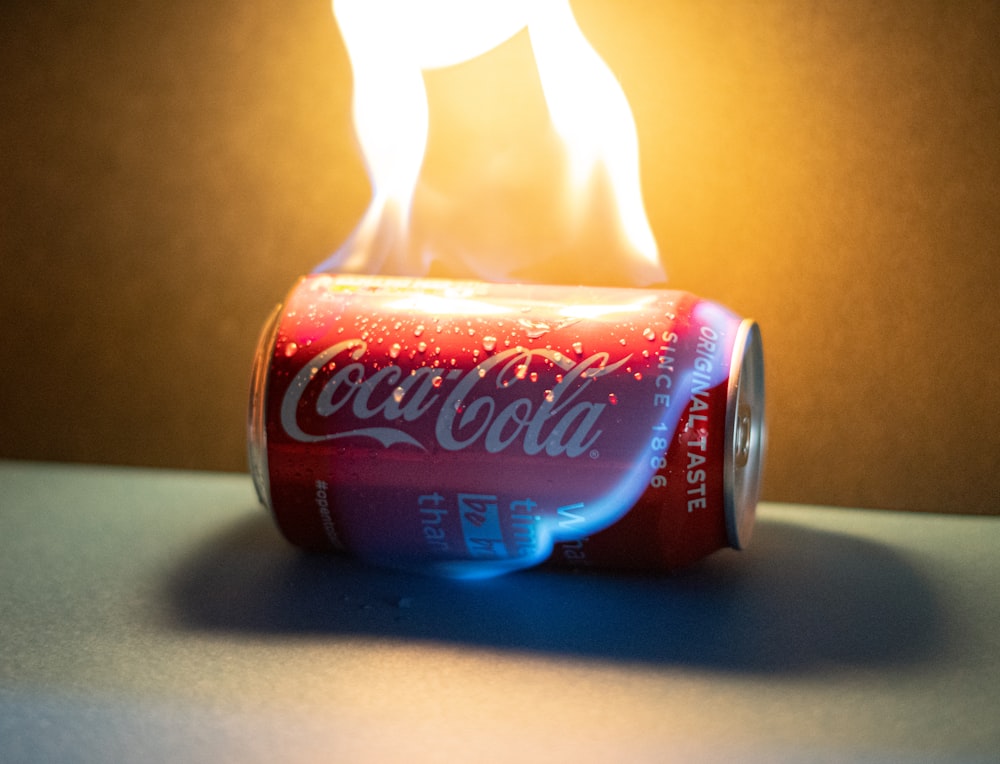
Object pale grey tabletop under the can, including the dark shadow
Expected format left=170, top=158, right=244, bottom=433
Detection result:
left=0, top=462, right=1000, bottom=764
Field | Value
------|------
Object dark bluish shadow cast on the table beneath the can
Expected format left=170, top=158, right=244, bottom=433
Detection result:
left=170, top=515, right=942, bottom=672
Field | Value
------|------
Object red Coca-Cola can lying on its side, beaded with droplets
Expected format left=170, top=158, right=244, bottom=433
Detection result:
left=249, top=274, right=765, bottom=578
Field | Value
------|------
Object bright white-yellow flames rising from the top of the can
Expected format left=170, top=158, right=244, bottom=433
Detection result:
left=317, top=0, right=665, bottom=285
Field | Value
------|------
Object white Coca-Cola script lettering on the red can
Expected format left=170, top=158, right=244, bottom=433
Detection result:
left=281, top=339, right=631, bottom=457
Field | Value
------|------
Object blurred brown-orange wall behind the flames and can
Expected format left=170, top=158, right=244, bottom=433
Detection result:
left=0, top=0, right=1000, bottom=513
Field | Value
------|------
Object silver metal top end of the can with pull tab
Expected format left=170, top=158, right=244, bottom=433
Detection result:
left=723, top=319, right=767, bottom=549
